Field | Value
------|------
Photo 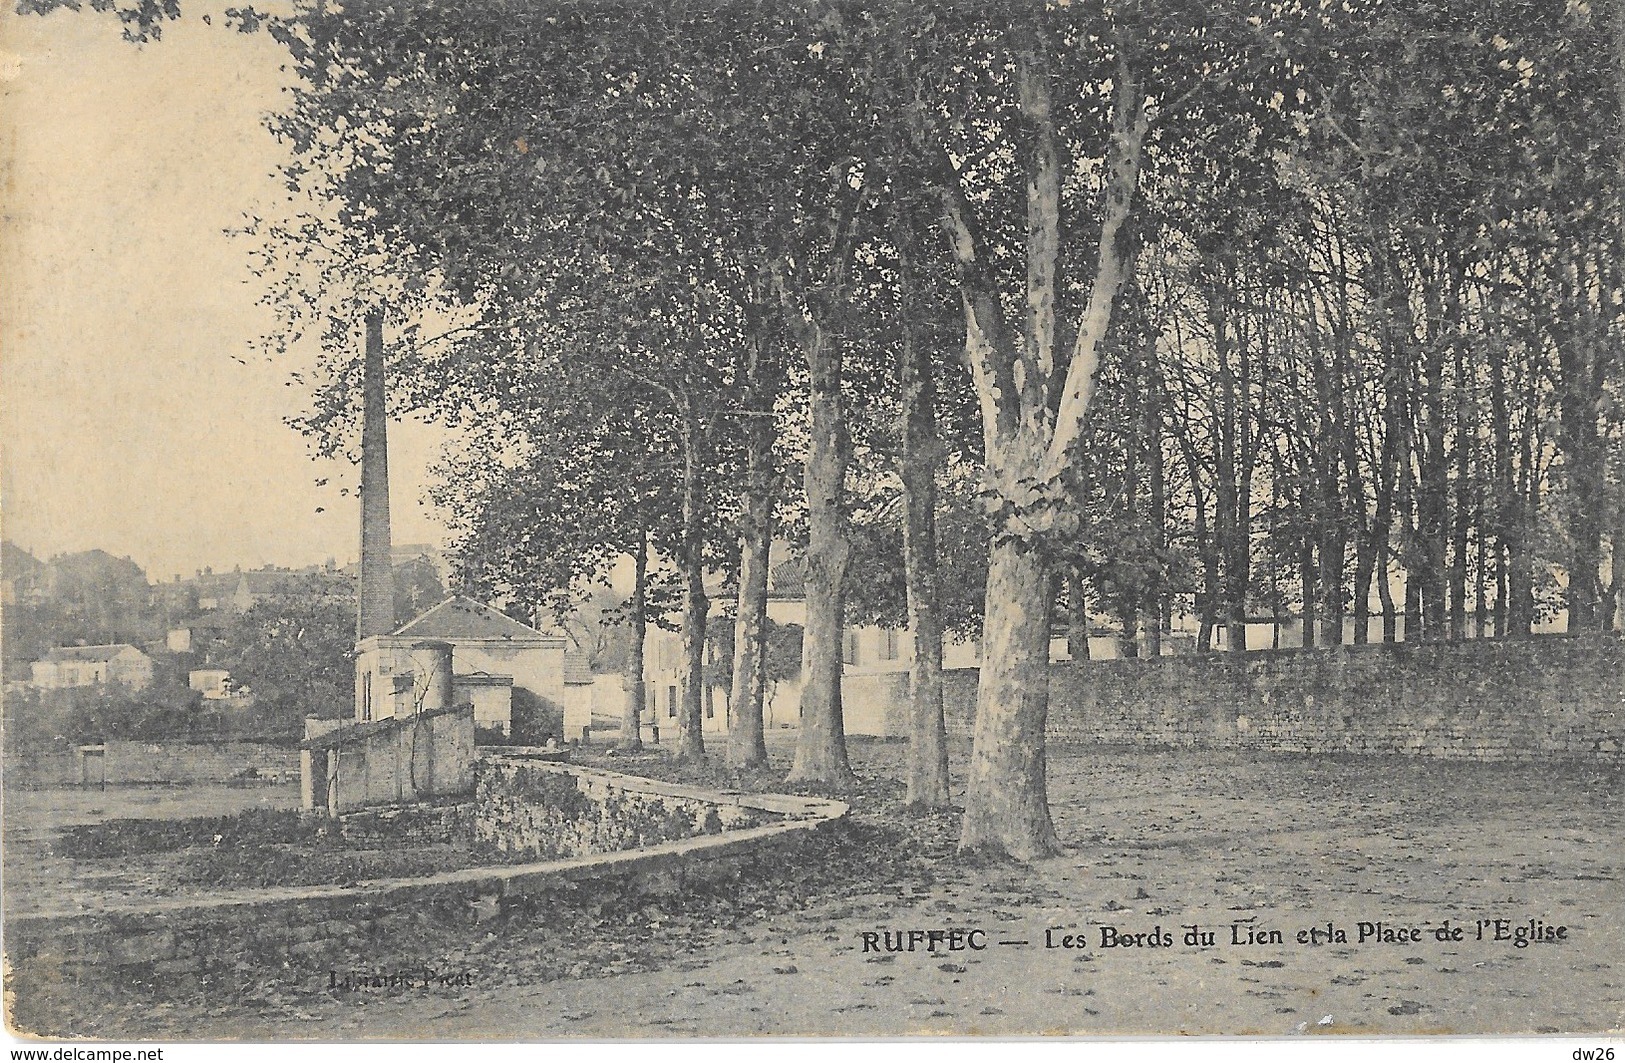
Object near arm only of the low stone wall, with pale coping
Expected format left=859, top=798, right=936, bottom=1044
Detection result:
left=5, top=806, right=845, bottom=1026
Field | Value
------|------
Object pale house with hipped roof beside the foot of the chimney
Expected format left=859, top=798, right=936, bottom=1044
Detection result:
left=356, top=597, right=592, bottom=738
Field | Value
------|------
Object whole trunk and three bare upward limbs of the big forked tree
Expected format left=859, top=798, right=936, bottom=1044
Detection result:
left=938, top=33, right=1149, bottom=858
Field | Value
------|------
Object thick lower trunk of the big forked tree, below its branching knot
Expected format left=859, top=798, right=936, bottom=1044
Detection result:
left=959, top=540, right=1060, bottom=858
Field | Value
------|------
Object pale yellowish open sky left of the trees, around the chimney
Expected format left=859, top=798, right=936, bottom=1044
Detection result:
left=0, top=3, right=444, bottom=580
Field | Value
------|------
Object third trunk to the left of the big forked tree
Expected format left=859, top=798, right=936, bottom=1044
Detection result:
left=728, top=503, right=774, bottom=767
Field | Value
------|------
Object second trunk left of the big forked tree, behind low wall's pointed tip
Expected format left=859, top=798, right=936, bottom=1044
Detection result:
left=790, top=335, right=853, bottom=787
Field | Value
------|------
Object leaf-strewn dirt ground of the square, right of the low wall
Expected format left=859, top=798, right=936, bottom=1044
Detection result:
left=6, top=743, right=1625, bottom=1040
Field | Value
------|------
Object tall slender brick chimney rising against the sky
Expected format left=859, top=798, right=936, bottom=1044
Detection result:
left=356, top=310, right=395, bottom=642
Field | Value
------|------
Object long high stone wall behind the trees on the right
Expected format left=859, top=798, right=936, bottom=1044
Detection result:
left=946, top=636, right=1625, bottom=764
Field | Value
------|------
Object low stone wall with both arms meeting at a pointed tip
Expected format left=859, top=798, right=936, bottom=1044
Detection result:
left=5, top=764, right=847, bottom=985
